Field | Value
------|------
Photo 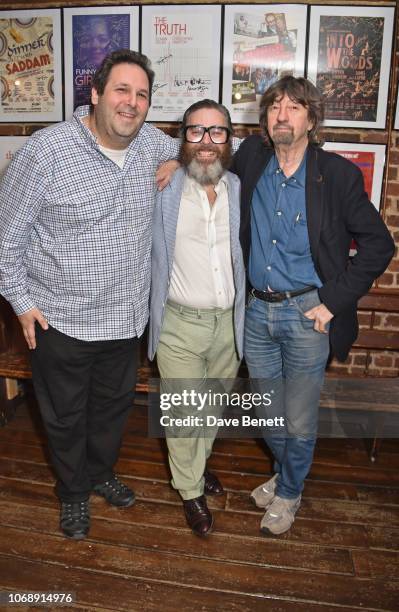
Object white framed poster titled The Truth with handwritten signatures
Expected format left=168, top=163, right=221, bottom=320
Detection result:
left=141, top=5, right=221, bottom=121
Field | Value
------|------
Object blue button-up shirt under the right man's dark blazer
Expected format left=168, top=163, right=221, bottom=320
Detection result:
left=249, top=153, right=322, bottom=291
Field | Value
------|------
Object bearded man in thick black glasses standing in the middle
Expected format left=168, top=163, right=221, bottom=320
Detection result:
left=148, top=100, right=245, bottom=536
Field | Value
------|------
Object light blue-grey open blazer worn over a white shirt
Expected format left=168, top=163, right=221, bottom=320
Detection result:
left=148, top=168, right=245, bottom=359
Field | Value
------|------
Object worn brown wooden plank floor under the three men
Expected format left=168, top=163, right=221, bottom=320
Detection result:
left=0, top=392, right=399, bottom=612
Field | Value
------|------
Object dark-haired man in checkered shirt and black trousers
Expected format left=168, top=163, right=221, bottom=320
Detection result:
left=0, top=50, right=179, bottom=539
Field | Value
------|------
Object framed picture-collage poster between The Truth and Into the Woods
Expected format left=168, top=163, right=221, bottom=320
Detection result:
left=223, top=4, right=307, bottom=124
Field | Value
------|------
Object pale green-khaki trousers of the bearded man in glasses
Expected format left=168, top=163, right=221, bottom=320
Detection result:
left=157, top=302, right=240, bottom=500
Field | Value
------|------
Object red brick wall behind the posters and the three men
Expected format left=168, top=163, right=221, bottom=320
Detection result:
left=0, top=0, right=399, bottom=377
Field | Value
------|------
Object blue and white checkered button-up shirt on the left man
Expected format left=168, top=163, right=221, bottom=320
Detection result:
left=0, top=107, right=180, bottom=340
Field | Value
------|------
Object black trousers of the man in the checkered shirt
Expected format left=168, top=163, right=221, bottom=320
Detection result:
left=31, top=325, right=139, bottom=502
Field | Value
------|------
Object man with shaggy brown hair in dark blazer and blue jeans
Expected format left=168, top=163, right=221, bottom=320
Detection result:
left=232, top=76, right=394, bottom=534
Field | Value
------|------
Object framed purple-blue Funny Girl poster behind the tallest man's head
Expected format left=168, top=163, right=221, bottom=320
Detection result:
left=64, top=6, right=139, bottom=119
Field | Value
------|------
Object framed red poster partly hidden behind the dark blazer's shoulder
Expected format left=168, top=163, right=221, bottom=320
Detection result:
left=323, top=142, right=385, bottom=210
